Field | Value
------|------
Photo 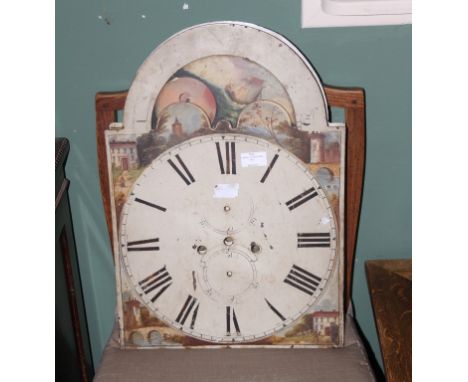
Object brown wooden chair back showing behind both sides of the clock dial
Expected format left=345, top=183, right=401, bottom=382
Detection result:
left=95, top=86, right=366, bottom=308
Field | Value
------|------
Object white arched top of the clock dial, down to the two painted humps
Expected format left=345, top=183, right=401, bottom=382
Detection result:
left=123, top=21, right=328, bottom=134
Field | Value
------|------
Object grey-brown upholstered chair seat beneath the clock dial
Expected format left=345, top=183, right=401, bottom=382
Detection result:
left=94, top=315, right=375, bottom=382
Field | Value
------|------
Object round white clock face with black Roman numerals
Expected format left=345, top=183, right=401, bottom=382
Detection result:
left=119, top=134, right=338, bottom=344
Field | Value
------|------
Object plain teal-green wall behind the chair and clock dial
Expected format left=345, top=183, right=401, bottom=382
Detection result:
left=56, top=0, right=411, bottom=365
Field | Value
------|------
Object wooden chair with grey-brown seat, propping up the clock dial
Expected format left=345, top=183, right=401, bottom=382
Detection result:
left=94, top=86, right=375, bottom=382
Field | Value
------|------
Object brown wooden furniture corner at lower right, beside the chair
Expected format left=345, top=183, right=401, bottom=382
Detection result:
left=366, top=260, right=412, bottom=382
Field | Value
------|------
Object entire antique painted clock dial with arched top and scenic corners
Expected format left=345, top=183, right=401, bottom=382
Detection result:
left=106, top=22, right=345, bottom=348
